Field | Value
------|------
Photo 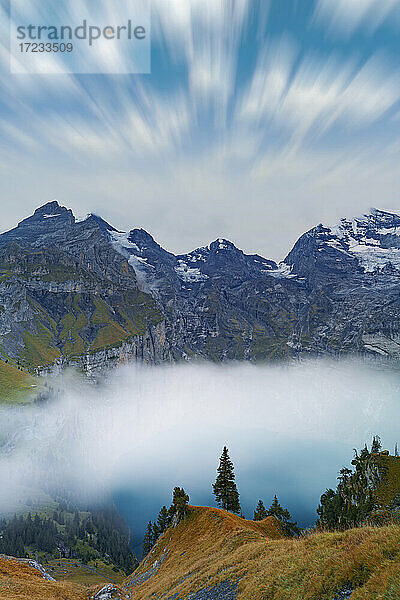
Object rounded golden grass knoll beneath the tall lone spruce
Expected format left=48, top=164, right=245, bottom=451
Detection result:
left=126, top=507, right=281, bottom=600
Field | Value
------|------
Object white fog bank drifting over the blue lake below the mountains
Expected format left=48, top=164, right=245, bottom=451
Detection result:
left=0, top=361, right=400, bottom=536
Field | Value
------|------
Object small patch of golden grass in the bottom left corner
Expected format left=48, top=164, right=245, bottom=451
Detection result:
left=0, top=558, right=90, bottom=600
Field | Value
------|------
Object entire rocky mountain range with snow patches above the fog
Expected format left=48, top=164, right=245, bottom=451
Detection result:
left=0, top=201, right=400, bottom=386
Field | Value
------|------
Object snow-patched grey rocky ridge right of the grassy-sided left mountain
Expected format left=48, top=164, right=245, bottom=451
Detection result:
left=109, top=210, right=400, bottom=360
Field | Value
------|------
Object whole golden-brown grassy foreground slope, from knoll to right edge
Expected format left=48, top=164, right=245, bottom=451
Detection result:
left=126, top=507, right=400, bottom=600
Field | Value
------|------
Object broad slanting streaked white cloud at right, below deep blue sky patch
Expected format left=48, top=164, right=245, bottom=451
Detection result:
left=237, top=46, right=400, bottom=150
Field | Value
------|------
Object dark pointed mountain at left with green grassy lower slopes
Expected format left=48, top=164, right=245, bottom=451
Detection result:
left=0, top=202, right=169, bottom=372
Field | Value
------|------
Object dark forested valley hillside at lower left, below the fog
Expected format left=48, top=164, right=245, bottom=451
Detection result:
left=0, top=501, right=137, bottom=583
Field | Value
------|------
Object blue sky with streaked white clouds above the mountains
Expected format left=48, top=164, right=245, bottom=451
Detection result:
left=0, top=0, right=400, bottom=259
